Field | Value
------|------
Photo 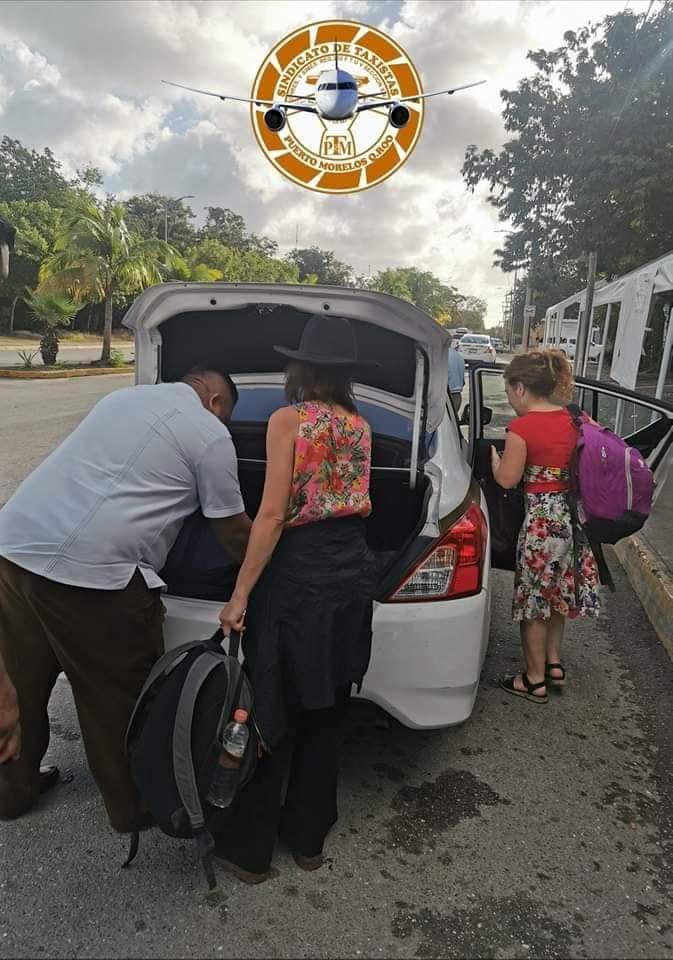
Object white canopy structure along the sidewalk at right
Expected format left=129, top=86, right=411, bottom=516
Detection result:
left=544, top=251, right=673, bottom=397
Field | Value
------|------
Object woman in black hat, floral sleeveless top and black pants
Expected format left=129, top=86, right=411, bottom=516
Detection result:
left=216, top=316, right=375, bottom=883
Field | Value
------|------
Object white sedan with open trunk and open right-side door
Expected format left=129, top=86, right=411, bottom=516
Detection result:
left=124, top=283, right=673, bottom=728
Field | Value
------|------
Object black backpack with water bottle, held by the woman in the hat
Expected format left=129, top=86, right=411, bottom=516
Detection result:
left=124, top=629, right=259, bottom=890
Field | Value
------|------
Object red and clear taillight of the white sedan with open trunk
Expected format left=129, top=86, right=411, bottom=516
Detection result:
left=388, top=503, right=487, bottom=603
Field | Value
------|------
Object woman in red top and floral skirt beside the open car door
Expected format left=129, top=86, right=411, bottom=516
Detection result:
left=491, top=350, right=600, bottom=703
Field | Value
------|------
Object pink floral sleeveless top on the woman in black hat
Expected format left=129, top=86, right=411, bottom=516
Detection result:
left=286, top=402, right=372, bottom=527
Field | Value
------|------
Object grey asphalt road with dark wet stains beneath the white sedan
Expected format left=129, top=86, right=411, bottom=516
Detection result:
left=0, top=378, right=673, bottom=960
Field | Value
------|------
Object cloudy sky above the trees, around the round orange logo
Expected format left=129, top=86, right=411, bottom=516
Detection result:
left=0, top=0, right=647, bottom=324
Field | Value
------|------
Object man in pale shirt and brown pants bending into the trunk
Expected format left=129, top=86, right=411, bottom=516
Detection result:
left=0, top=368, right=250, bottom=833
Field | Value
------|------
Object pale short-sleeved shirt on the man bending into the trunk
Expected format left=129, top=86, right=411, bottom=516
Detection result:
left=0, top=383, right=245, bottom=590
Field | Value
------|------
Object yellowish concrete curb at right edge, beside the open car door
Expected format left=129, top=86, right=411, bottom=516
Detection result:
left=613, top=536, right=673, bottom=660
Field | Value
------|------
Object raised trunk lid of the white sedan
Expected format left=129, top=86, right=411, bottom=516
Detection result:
left=124, top=283, right=449, bottom=436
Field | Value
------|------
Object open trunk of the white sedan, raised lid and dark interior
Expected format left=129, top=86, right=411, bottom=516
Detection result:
left=124, top=284, right=448, bottom=600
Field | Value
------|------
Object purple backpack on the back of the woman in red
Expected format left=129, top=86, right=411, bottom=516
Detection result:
left=570, top=408, right=654, bottom=543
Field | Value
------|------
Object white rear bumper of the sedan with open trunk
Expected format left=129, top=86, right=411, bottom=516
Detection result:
left=164, top=578, right=490, bottom=729
